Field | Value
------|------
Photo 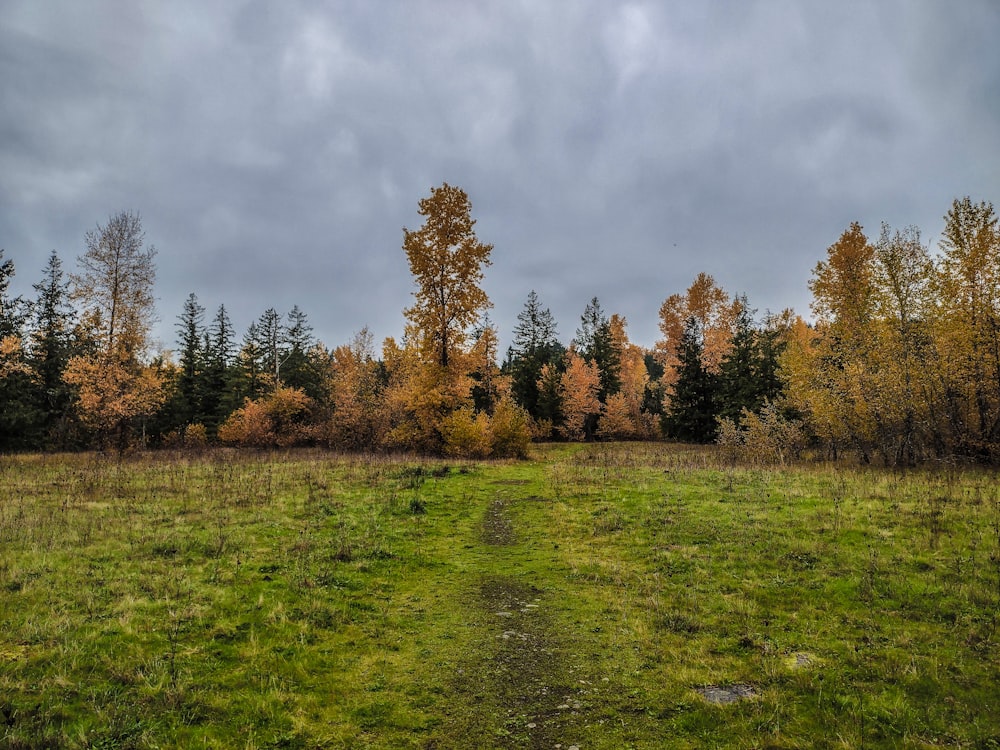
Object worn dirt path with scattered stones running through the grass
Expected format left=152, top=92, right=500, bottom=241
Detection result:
left=438, top=499, right=584, bottom=750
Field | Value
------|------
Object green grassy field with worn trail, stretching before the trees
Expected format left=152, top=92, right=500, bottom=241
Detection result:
left=0, top=444, right=1000, bottom=750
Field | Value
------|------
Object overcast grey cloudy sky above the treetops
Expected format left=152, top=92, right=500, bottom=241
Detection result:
left=0, top=0, right=1000, bottom=356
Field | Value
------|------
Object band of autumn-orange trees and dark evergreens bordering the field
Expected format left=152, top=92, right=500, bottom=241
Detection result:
left=0, top=183, right=1000, bottom=466
